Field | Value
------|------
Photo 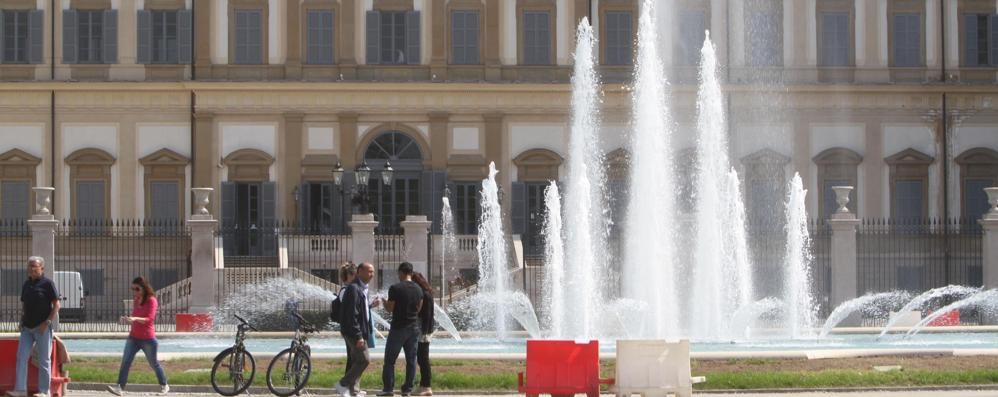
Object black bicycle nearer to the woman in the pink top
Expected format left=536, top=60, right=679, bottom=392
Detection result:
left=211, top=316, right=257, bottom=396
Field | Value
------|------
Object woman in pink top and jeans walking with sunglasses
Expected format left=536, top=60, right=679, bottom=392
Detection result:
left=107, top=277, right=170, bottom=396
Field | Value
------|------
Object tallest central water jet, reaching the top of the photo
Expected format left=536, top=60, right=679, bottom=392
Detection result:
left=621, top=0, right=681, bottom=337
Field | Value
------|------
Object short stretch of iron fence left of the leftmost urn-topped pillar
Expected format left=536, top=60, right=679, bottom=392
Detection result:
left=0, top=220, right=31, bottom=331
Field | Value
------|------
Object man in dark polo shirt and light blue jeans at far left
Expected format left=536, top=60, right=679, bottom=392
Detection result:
left=7, top=256, right=59, bottom=397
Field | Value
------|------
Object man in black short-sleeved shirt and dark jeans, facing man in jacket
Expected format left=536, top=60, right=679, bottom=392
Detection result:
left=378, top=262, right=423, bottom=396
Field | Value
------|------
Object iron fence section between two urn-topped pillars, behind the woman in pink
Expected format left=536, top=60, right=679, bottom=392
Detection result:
left=54, top=220, right=191, bottom=332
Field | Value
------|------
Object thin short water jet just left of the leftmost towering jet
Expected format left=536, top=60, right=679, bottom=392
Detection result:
left=544, top=181, right=568, bottom=336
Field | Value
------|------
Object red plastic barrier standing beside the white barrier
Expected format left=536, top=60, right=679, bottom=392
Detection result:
left=518, top=340, right=613, bottom=397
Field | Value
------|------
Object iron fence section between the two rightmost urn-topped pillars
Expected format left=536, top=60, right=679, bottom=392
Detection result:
left=856, top=219, right=983, bottom=294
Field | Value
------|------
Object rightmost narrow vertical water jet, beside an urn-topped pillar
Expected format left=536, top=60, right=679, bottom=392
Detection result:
left=783, top=173, right=817, bottom=338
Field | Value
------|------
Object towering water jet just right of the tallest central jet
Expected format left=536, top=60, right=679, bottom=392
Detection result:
left=689, top=32, right=751, bottom=339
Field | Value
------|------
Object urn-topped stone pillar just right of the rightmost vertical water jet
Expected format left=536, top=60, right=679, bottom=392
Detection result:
left=828, top=186, right=859, bottom=307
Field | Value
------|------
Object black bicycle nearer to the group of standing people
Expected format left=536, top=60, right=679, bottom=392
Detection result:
left=267, top=312, right=319, bottom=397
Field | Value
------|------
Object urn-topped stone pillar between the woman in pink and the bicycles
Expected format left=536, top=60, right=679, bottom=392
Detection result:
left=187, top=188, right=224, bottom=313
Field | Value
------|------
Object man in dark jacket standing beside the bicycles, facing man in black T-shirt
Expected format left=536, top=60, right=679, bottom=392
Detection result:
left=336, top=262, right=374, bottom=397
